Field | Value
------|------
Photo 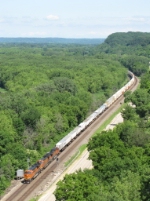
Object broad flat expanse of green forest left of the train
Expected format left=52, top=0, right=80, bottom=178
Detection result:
left=0, top=44, right=128, bottom=194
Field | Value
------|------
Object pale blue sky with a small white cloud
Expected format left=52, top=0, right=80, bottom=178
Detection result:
left=0, top=0, right=150, bottom=38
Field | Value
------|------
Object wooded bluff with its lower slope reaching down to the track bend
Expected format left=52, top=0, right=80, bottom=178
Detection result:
left=100, top=32, right=150, bottom=76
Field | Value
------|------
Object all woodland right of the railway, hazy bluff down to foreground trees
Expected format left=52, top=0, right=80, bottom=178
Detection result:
left=55, top=32, right=150, bottom=201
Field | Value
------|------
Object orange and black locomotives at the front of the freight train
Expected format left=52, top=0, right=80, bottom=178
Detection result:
left=24, top=147, right=59, bottom=183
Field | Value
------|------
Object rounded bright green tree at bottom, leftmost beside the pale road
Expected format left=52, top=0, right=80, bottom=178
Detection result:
left=56, top=171, right=99, bottom=201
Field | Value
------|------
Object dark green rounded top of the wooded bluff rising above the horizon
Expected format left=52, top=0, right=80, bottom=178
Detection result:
left=100, top=32, right=150, bottom=58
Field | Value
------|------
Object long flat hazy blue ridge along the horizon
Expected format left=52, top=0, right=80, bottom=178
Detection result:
left=0, top=37, right=105, bottom=45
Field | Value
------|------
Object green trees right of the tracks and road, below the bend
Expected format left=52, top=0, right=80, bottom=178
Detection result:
left=55, top=73, right=150, bottom=201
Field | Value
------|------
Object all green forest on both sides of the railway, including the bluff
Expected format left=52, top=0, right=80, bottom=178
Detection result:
left=0, top=32, right=150, bottom=201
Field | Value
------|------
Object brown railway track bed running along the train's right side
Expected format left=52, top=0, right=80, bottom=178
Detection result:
left=2, top=74, right=138, bottom=201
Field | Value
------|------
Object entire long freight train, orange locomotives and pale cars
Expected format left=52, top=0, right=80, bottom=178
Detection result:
left=24, top=72, right=135, bottom=183
